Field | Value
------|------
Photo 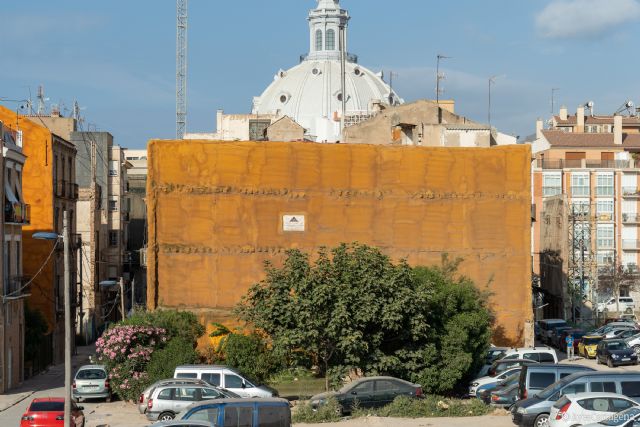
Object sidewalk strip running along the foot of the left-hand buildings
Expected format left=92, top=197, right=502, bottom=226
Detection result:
left=0, top=345, right=95, bottom=412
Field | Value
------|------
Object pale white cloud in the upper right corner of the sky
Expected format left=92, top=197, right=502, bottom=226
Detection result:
left=536, top=0, right=640, bottom=38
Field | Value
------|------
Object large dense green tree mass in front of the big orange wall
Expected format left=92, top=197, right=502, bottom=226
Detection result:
left=236, top=244, right=492, bottom=394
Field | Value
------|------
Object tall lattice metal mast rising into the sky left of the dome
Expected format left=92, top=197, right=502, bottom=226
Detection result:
left=176, top=0, right=189, bottom=139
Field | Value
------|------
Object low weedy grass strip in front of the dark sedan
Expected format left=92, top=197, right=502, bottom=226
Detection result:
left=352, top=396, right=493, bottom=418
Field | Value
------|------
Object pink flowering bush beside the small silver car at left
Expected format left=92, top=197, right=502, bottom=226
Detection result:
left=96, top=325, right=168, bottom=400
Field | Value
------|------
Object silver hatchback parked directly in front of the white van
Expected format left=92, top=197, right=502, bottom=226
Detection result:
left=146, top=384, right=235, bottom=421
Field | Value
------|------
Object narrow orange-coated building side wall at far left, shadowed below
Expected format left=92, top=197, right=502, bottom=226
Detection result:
left=0, top=106, right=56, bottom=329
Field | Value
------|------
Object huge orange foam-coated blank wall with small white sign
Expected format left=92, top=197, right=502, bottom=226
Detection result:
left=147, top=141, right=532, bottom=345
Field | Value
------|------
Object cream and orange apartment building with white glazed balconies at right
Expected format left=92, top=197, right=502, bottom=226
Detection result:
left=532, top=106, right=640, bottom=317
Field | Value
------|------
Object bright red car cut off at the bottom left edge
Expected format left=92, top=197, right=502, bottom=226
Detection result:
left=20, top=397, right=84, bottom=427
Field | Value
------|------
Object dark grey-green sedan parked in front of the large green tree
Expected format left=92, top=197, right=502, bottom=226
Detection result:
left=310, top=377, right=423, bottom=414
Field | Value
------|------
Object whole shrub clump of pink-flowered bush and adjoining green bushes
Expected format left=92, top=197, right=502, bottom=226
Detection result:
left=96, top=310, right=204, bottom=400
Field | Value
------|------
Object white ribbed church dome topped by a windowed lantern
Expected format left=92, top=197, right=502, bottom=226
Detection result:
left=252, top=0, right=404, bottom=142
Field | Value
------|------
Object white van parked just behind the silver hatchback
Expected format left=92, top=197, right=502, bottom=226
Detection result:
left=173, top=365, right=278, bottom=397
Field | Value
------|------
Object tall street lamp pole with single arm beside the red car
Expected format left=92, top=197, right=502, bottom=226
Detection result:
left=32, top=210, right=71, bottom=427
